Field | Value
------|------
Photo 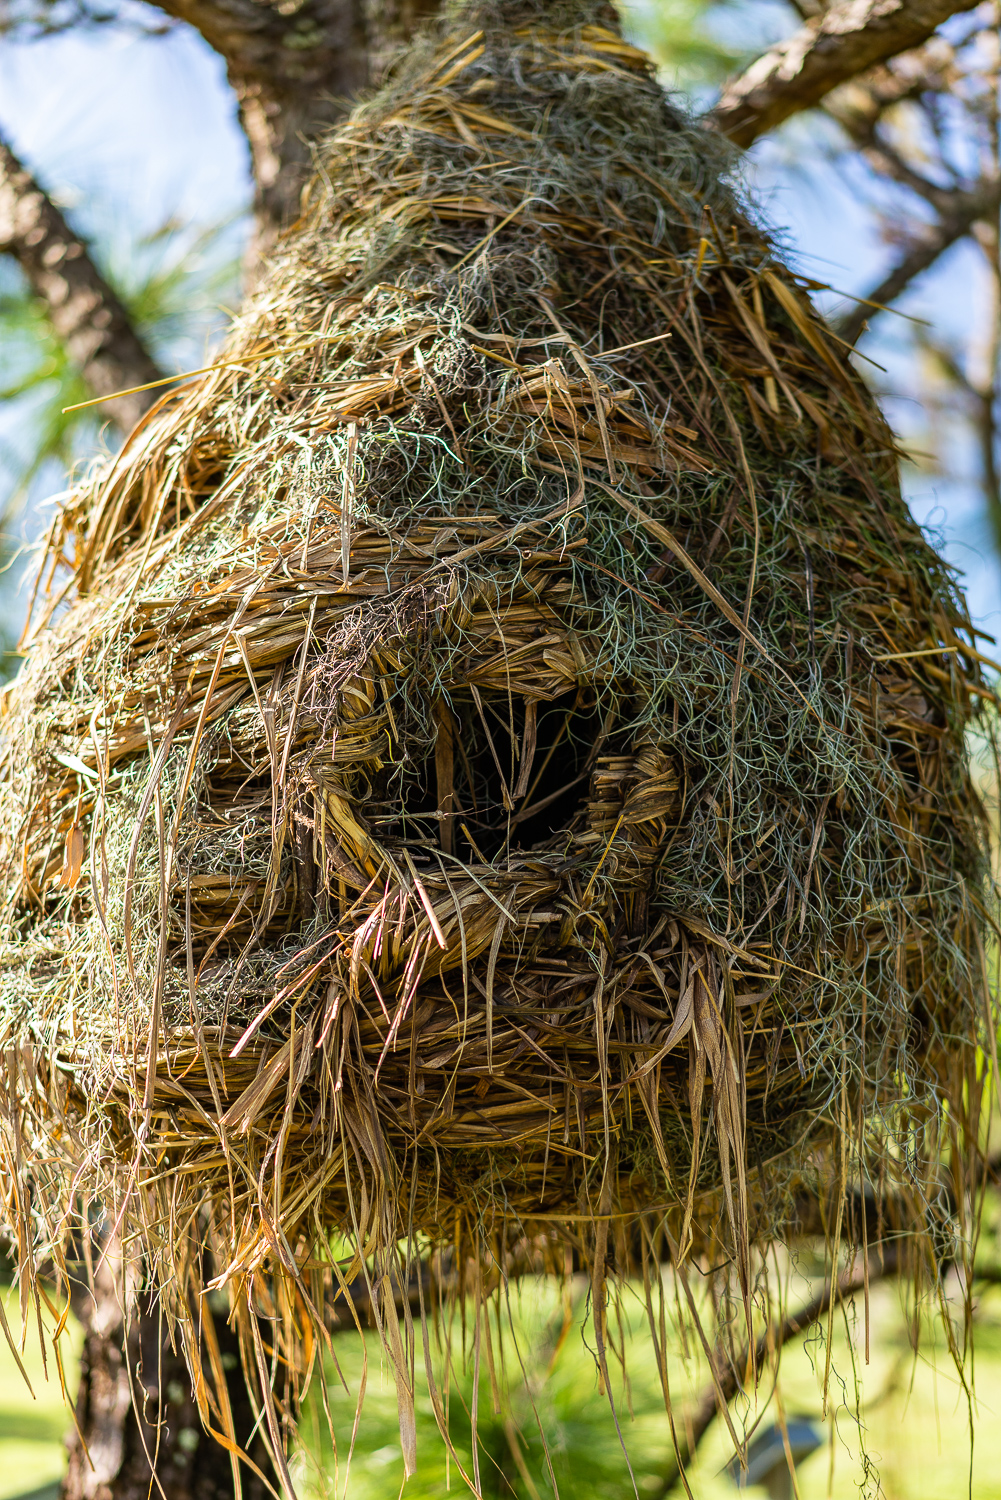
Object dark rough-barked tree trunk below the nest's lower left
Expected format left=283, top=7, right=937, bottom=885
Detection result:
left=62, top=1248, right=279, bottom=1500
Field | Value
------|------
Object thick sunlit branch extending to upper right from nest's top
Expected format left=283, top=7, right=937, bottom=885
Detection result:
left=717, top=0, right=977, bottom=146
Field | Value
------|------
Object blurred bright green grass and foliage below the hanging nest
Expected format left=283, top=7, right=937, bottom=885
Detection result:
left=294, top=1259, right=1001, bottom=1500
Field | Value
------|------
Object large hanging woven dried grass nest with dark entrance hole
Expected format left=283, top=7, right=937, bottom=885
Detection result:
left=0, top=0, right=990, bottom=1476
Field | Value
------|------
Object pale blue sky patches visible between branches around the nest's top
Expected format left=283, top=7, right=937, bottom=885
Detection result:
left=0, top=6, right=1001, bottom=633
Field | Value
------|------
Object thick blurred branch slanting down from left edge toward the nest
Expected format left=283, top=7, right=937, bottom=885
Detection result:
left=0, top=129, right=161, bottom=429
